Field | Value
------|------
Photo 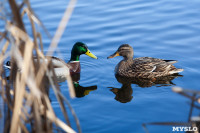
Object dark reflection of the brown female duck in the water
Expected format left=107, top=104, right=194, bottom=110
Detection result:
left=108, top=74, right=182, bottom=103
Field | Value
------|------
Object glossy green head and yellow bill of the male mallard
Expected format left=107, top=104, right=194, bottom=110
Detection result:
left=70, top=42, right=97, bottom=61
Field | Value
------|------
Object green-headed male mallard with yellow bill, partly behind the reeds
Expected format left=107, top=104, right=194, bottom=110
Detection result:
left=5, top=42, right=97, bottom=79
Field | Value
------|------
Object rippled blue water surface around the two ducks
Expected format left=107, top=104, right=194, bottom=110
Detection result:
left=27, top=0, right=200, bottom=133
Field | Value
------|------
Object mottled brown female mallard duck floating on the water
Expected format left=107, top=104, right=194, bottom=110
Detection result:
left=108, top=44, right=183, bottom=79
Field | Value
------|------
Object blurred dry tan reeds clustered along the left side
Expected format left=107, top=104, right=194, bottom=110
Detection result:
left=0, top=0, right=81, bottom=133
